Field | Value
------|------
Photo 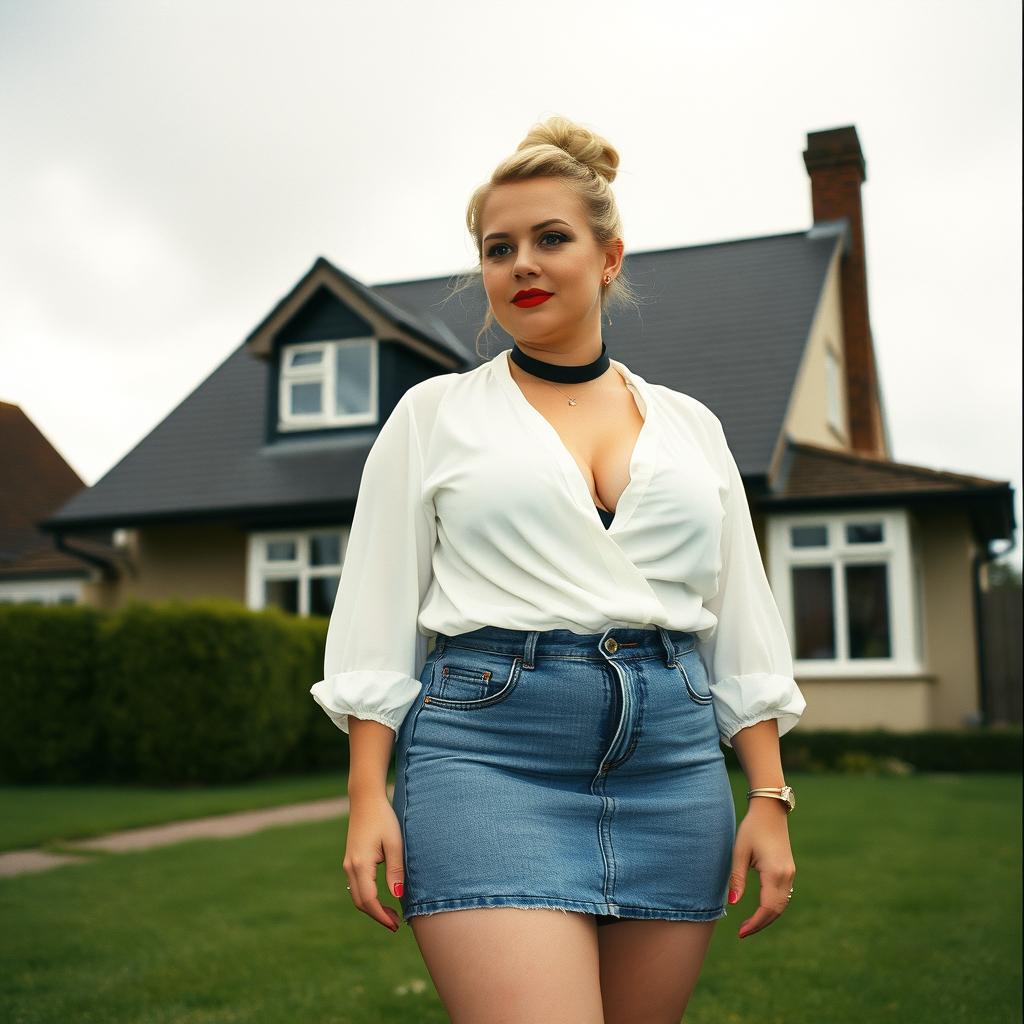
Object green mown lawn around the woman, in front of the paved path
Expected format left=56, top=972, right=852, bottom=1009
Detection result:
left=0, top=772, right=1021, bottom=1024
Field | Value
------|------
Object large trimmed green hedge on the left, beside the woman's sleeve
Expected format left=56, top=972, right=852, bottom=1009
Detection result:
left=0, top=599, right=348, bottom=785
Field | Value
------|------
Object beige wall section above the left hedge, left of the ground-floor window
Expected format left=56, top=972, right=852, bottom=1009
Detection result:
left=85, top=524, right=246, bottom=608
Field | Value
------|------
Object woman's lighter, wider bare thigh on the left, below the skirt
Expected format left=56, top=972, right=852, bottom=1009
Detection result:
left=409, top=906, right=602, bottom=1024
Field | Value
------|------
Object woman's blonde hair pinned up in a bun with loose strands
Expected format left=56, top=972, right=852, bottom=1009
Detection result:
left=445, top=116, right=636, bottom=358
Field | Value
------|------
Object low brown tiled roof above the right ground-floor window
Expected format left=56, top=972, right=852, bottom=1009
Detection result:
left=758, top=439, right=1016, bottom=544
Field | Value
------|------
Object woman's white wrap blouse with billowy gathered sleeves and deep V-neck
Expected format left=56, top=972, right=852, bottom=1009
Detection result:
left=310, top=349, right=805, bottom=746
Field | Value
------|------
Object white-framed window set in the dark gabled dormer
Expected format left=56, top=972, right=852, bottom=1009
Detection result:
left=278, top=338, right=377, bottom=430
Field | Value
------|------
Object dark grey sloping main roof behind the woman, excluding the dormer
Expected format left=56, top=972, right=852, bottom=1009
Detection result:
left=39, top=221, right=845, bottom=529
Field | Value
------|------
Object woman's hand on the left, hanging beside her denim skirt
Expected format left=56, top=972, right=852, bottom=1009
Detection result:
left=343, top=792, right=406, bottom=932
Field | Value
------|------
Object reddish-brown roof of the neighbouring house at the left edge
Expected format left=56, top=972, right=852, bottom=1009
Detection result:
left=0, top=401, right=102, bottom=580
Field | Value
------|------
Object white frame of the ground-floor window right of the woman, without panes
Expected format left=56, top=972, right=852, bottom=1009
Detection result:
left=767, top=508, right=923, bottom=678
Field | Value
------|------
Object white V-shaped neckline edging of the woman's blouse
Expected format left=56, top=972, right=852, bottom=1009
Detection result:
left=494, top=349, right=656, bottom=535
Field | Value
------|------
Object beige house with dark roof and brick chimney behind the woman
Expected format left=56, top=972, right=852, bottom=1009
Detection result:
left=41, top=127, right=1016, bottom=730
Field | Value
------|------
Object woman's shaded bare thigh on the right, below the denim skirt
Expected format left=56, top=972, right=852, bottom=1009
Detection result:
left=595, top=921, right=718, bottom=1024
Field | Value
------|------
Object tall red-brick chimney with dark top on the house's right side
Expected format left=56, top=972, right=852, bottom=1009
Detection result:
left=804, top=125, right=889, bottom=457
